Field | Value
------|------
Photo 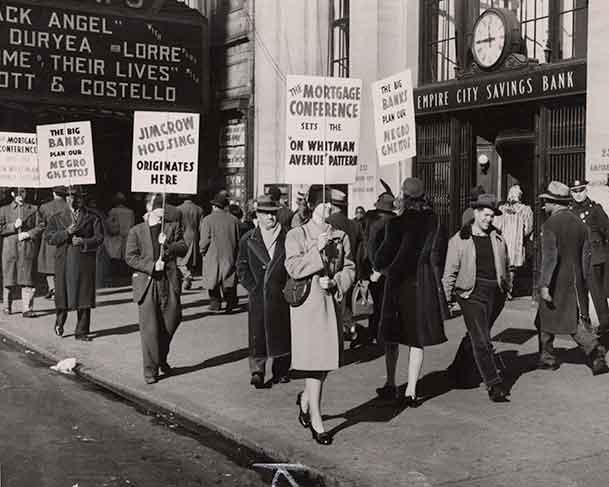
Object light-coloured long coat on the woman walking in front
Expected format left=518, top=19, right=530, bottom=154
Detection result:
left=285, top=221, right=355, bottom=371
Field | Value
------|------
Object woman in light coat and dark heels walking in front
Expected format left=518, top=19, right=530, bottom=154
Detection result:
left=285, top=185, right=355, bottom=445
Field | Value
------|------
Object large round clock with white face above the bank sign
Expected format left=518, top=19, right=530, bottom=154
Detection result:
left=472, top=8, right=520, bottom=69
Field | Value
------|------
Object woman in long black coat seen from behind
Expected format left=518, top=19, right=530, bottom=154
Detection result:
left=372, top=178, right=449, bottom=407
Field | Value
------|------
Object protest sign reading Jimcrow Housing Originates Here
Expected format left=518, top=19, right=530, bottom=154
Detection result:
left=131, top=112, right=199, bottom=194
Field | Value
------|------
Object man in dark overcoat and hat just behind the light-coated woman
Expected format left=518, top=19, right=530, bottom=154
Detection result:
left=237, top=195, right=290, bottom=389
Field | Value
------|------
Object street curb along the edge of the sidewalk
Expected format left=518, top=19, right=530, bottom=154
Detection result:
left=0, top=328, right=342, bottom=487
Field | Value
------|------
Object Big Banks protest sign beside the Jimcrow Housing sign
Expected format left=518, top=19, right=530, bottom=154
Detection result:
left=36, top=122, right=95, bottom=188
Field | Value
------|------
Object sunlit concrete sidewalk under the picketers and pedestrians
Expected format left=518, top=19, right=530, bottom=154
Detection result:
left=0, top=281, right=609, bottom=487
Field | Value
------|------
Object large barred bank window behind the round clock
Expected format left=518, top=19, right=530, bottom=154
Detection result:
left=420, top=0, right=588, bottom=83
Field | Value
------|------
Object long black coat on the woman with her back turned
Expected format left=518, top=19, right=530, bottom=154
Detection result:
left=373, top=210, right=448, bottom=347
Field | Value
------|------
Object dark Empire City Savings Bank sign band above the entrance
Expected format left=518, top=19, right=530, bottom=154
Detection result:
left=414, top=61, right=586, bottom=115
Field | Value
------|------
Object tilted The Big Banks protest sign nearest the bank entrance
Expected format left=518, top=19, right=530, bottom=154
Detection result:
left=372, top=69, right=416, bottom=166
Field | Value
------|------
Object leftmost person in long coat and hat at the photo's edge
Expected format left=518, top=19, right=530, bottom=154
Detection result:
left=0, top=188, right=42, bottom=318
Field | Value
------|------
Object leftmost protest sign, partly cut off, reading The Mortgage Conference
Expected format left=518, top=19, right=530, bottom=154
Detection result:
left=0, top=132, right=40, bottom=188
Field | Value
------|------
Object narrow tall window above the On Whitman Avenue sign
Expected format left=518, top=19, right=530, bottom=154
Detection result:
left=328, top=0, right=349, bottom=78
